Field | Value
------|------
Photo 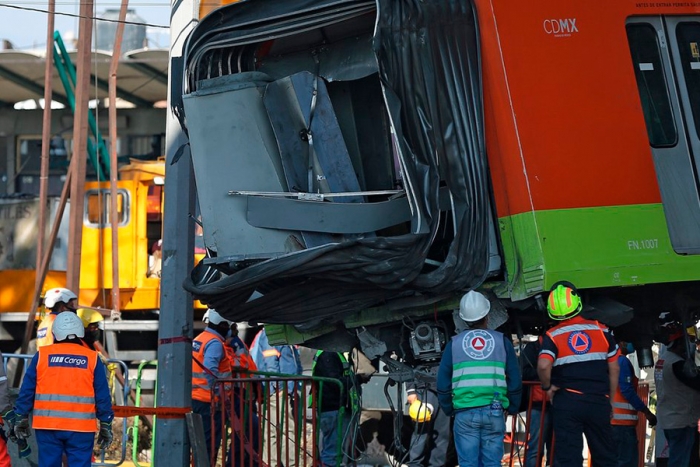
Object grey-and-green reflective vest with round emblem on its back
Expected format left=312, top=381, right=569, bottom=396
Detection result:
left=451, top=329, right=509, bottom=409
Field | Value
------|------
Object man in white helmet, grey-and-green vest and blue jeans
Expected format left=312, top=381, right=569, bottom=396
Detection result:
left=437, top=291, right=522, bottom=467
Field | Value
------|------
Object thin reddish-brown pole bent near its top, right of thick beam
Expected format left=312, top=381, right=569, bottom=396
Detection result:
left=109, top=0, right=129, bottom=319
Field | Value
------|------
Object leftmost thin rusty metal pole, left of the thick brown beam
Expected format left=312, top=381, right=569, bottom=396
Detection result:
left=35, top=0, right=56, bottom=282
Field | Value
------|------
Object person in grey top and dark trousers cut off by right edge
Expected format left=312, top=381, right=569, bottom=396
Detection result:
left=652, top=327, right=700, bottom=467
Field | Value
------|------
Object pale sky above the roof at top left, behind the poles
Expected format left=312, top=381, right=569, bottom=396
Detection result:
left=0, top=0, right=170, bottom=50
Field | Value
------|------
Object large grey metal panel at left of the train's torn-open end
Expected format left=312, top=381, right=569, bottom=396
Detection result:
left=184, top=75, right=295, bottom=255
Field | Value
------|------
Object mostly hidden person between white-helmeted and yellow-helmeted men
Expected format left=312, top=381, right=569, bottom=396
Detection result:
left=521, top=336, right=552, bottom=467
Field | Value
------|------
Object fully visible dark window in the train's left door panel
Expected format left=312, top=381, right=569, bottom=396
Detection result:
left=627, top=24, right=678, bottom=147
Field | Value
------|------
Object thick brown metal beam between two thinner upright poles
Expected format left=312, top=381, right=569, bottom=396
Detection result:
left=66, top=0, right=94, bottom=296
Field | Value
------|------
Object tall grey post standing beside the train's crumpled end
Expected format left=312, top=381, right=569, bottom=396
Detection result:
left=154, top=0, right=198, bottom=466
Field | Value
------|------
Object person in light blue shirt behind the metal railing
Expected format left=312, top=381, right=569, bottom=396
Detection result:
left=250, top=328, right=313, bottom=467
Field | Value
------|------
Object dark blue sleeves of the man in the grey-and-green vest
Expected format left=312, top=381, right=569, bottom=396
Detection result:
left=437, top=336, right=522, bottom=415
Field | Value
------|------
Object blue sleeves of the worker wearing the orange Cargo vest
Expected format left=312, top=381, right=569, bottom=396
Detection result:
left=15, top=343, right=114, bottom=424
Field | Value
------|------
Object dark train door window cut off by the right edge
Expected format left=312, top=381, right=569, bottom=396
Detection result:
left=676, top=22, right=700, bottom=137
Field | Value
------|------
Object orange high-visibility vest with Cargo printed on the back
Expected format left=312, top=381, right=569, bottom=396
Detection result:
left=32, top=343, right=98, bottom=433
